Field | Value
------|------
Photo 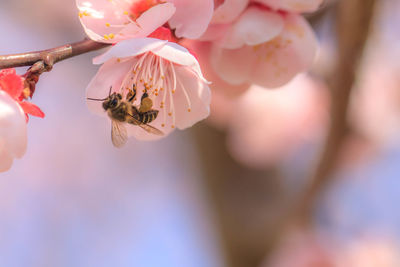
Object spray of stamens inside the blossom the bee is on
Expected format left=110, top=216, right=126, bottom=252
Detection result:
left=120, top=52, right=191, bottom=128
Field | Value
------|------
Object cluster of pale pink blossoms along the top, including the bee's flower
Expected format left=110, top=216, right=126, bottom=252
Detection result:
left=77, top=0, right=322, bottom=140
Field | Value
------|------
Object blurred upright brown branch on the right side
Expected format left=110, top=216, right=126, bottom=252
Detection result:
left=267, top=0, right=376, bottom=260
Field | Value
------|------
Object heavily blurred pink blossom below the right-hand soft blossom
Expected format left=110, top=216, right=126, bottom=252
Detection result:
left=217, top=75, right=328, bottom=169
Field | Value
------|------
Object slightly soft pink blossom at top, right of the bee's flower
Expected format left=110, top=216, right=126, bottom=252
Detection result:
left=195, top=0, right=321, bottom=88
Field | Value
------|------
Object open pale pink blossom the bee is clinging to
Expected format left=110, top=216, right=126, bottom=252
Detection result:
left=87, top=38, right=210, bottom=140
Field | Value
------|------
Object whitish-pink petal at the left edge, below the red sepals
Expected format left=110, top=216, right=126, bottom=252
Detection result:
left=0, top=91, right=27, bottom=165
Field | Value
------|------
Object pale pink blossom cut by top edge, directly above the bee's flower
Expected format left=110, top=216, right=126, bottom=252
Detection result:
left=76, top=0, right=214, bottom=43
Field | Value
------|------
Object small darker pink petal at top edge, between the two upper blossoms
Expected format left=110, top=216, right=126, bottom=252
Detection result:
left=211, top=0, right=249, bottom=24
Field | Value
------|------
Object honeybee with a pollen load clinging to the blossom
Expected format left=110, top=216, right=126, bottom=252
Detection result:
left=87, top=85, right=164, bottom=147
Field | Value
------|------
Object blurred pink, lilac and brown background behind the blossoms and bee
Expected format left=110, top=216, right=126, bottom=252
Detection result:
left=0, top=0, right=400, bottom=267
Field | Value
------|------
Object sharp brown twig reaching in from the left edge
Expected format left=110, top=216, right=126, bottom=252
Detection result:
left=0, top=39, right=109, bottom=71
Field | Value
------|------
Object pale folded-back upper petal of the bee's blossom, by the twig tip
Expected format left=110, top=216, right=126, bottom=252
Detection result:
left=93, top=38, right=167, bottom=64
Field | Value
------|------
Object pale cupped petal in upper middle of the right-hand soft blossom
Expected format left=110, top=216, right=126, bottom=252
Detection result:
left=218, top=7, right=284, bottom=49
